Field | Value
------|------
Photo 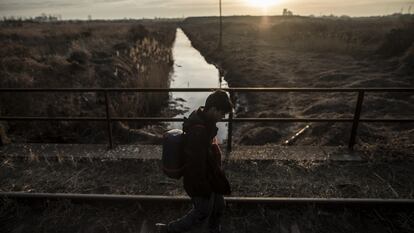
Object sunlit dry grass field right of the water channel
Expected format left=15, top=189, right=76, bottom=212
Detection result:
left=182, top=15, right=414, bottom=151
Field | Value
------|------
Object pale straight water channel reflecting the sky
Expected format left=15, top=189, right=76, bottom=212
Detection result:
left=170, top=29, right=231, bottom=140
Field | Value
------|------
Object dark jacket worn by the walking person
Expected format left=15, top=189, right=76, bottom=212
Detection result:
left=183, top=107, right=231, bottom=197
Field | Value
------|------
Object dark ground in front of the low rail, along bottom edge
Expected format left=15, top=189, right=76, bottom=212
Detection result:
left=0, top=198, right=414, bottom=233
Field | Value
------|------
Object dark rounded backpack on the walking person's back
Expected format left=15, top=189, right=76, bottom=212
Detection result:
left=161, top=125, right=204, bottom=180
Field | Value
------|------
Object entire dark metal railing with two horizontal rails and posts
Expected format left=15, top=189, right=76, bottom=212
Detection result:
left=0, top=88, right=414, bottom=151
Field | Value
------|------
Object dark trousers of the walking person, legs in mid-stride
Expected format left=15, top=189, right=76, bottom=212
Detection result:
left=168, top=193, right=225, bottom=233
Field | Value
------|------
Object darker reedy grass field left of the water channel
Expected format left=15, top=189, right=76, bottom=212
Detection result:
left=0, top=21, right=176, bottom=143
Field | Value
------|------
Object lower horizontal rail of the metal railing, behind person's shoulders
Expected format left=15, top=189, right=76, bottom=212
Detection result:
left=0, top=116, right=414, bottom=122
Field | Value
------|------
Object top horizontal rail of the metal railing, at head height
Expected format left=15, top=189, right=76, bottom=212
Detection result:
left=0, top=87, right=414, bottom=92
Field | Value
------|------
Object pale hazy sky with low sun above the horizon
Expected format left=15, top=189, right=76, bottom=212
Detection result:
left=0, top=0, right=414, bottom=19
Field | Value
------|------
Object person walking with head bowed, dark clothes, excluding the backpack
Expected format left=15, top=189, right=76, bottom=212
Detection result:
left=156, top=90, right=233, bottom=233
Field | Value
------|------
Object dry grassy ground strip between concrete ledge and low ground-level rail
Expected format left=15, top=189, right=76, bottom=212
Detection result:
left=0, top=154, right=414, bottom=198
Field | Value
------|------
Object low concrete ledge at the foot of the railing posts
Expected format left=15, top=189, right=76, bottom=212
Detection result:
left=0, top=144, right=362, bottom=161
